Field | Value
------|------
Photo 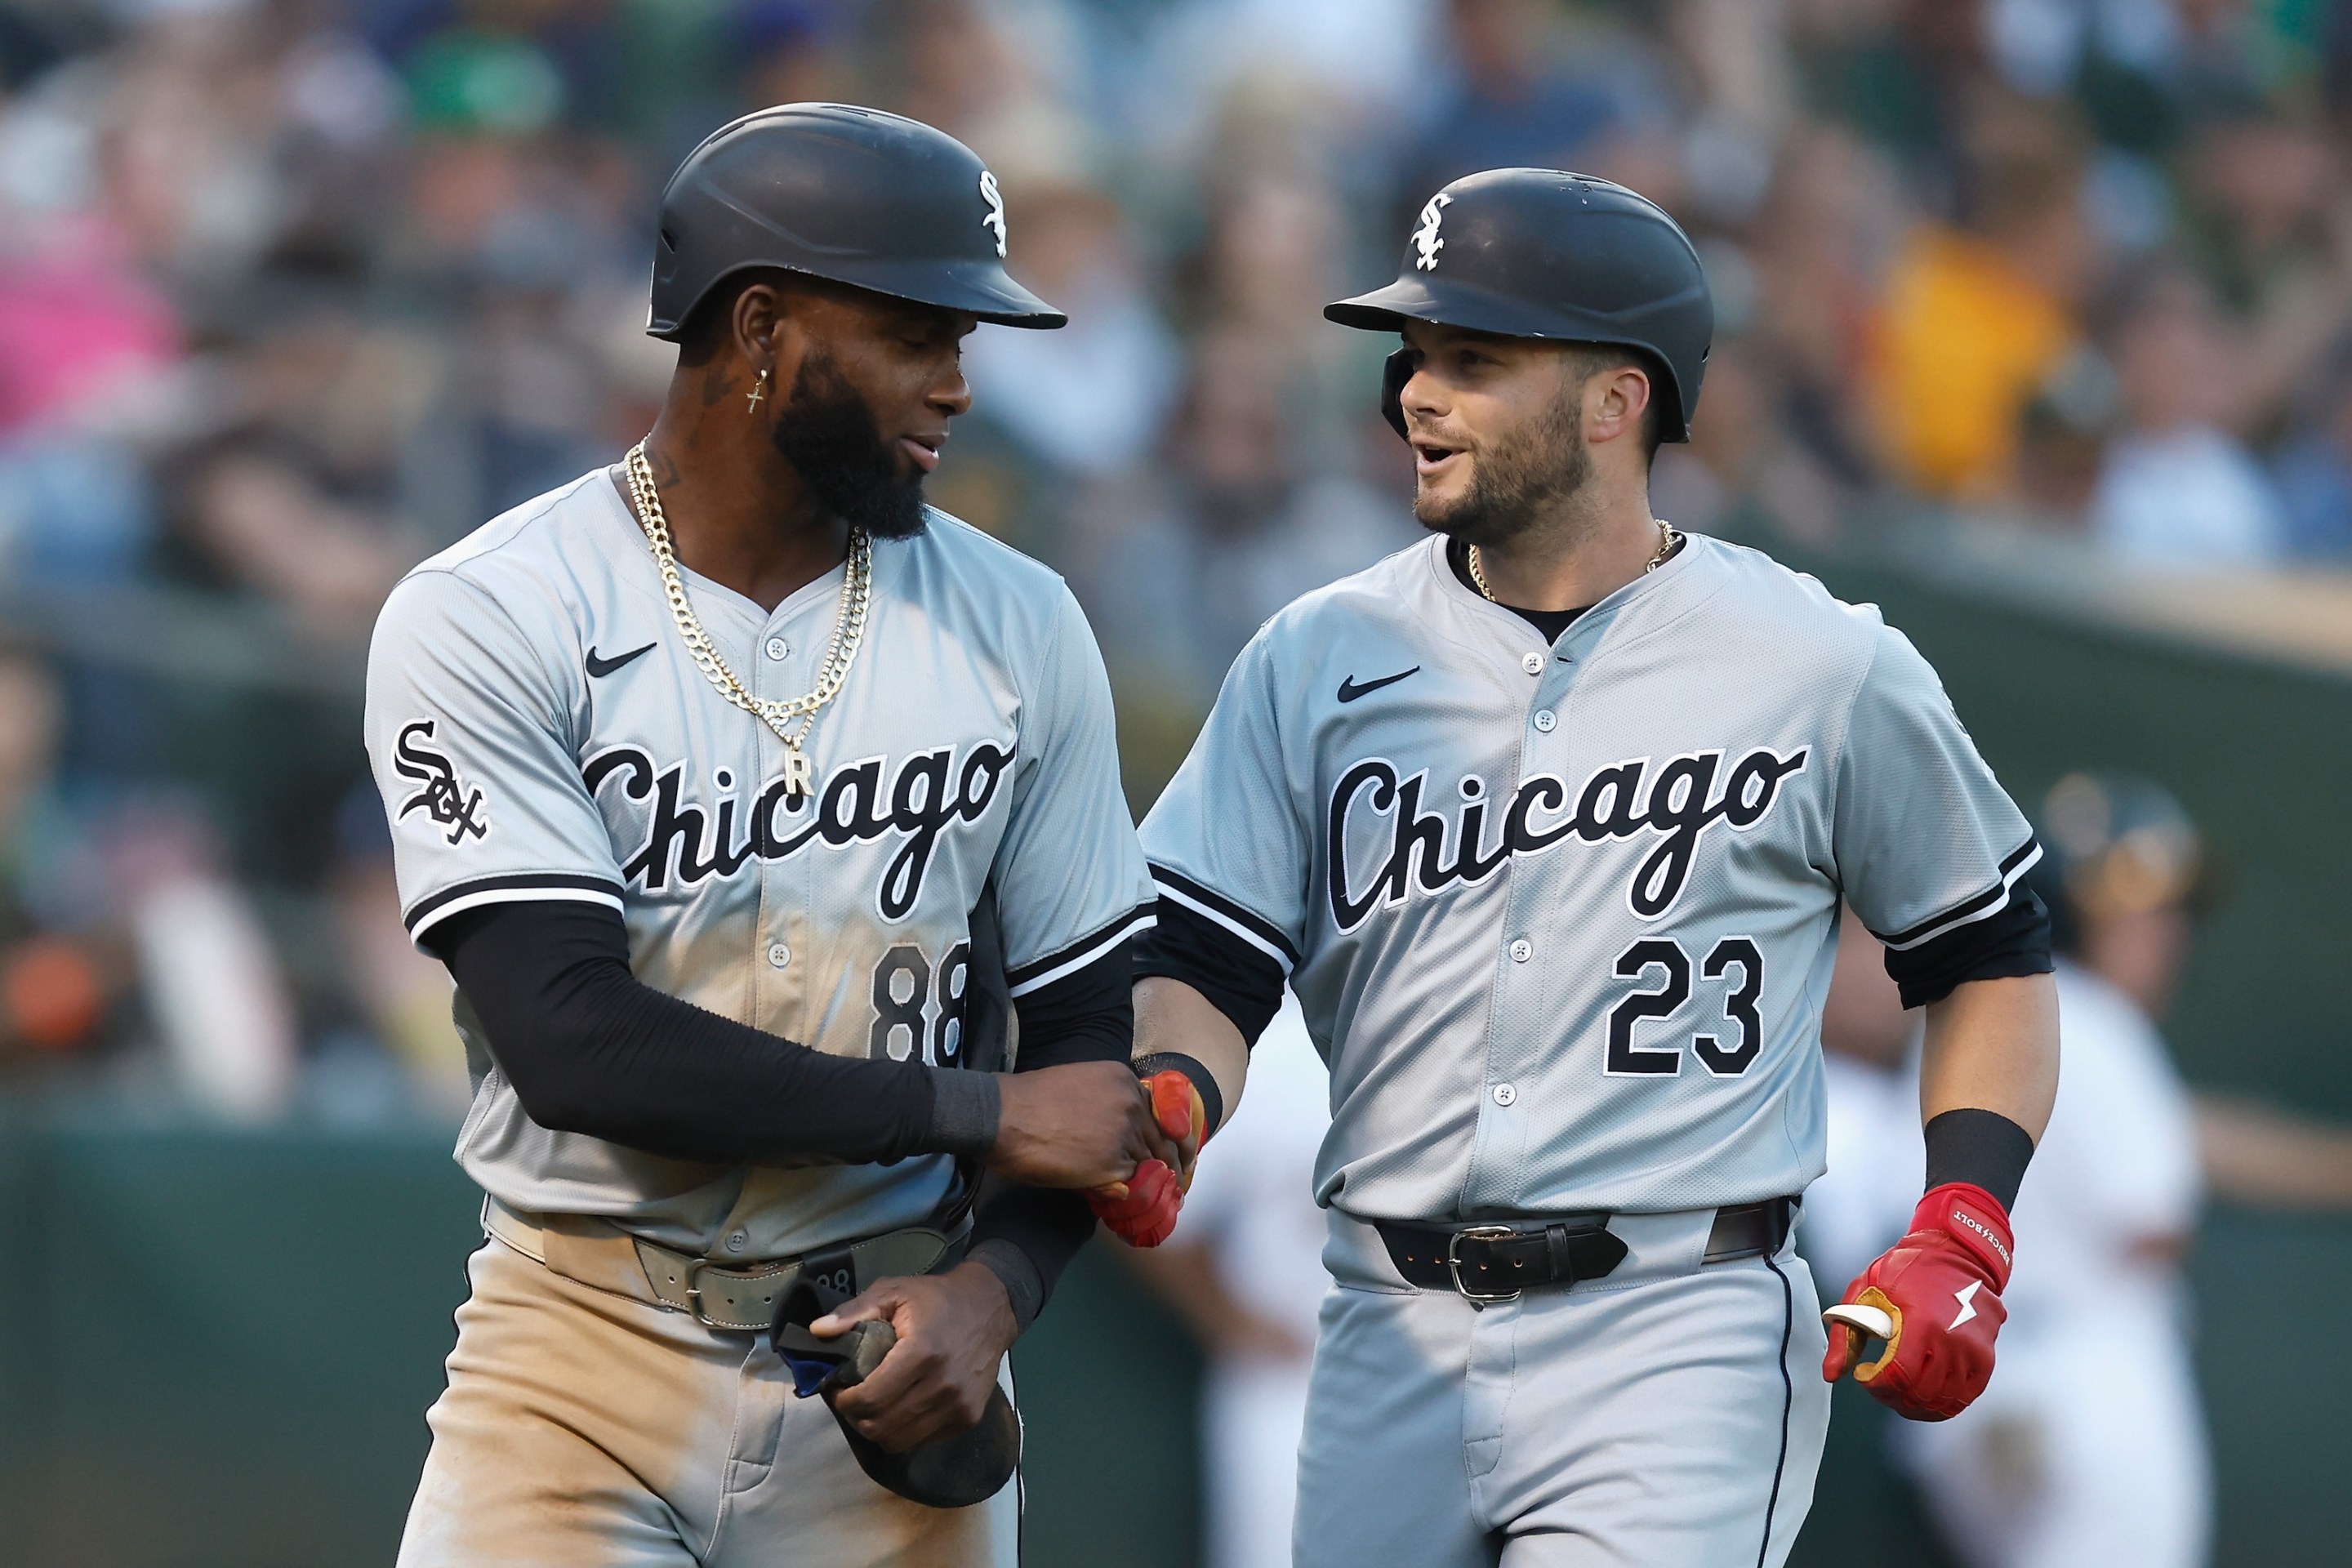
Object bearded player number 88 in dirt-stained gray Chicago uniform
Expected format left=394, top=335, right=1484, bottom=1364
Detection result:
left=367, top=104, right=1176, bottom=1568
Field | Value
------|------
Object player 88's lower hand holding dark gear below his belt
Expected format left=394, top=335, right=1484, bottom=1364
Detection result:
left=809, top=1263, right=1021, bottom=1453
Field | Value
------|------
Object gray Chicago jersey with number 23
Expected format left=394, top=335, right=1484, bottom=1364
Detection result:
left=1143, top=536, right=2039, bottom=1220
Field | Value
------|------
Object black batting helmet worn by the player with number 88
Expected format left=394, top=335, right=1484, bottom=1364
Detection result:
left=644, top=104, right=1070, bottom=343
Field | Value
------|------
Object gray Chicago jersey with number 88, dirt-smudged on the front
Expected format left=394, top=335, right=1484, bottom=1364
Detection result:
left=367, top=470, right=1152, bottom=1258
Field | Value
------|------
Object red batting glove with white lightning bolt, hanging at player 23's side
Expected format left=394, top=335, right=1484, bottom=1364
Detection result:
left=1820, top=1183, right=2011, bottom=1420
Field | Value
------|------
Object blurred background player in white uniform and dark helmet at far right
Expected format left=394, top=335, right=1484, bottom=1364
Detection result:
left=1895, top=776, right=2213, bottom=1568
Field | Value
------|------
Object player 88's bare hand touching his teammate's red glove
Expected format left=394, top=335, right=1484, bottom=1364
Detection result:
left=986, top=1062, right=1183, bottom=1187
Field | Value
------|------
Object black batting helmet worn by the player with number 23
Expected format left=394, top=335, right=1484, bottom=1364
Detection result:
left=1324, top=169, right=1715, bottom=442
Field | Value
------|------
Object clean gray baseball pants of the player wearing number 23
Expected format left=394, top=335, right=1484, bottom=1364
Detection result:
left=1294, top=1210, right=1830, bottom=1568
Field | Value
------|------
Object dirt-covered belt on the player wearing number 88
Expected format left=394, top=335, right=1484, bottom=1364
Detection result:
left=482, top=1199, right=971, bottom=1333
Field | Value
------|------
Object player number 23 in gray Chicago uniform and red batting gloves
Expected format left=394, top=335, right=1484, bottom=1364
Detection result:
left=1136, top=169, right=2056, bottom=1568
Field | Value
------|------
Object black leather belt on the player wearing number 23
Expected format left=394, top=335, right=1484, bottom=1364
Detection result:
left=1374, top=1199, right=1797, bottom=1305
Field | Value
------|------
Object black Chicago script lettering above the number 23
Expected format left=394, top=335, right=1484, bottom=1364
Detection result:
left=1326, top=747, right=1806, bottom=931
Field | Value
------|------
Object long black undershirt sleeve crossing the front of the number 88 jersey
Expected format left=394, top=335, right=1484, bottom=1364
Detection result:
left=425, top=900, right=997, bottom=1164
